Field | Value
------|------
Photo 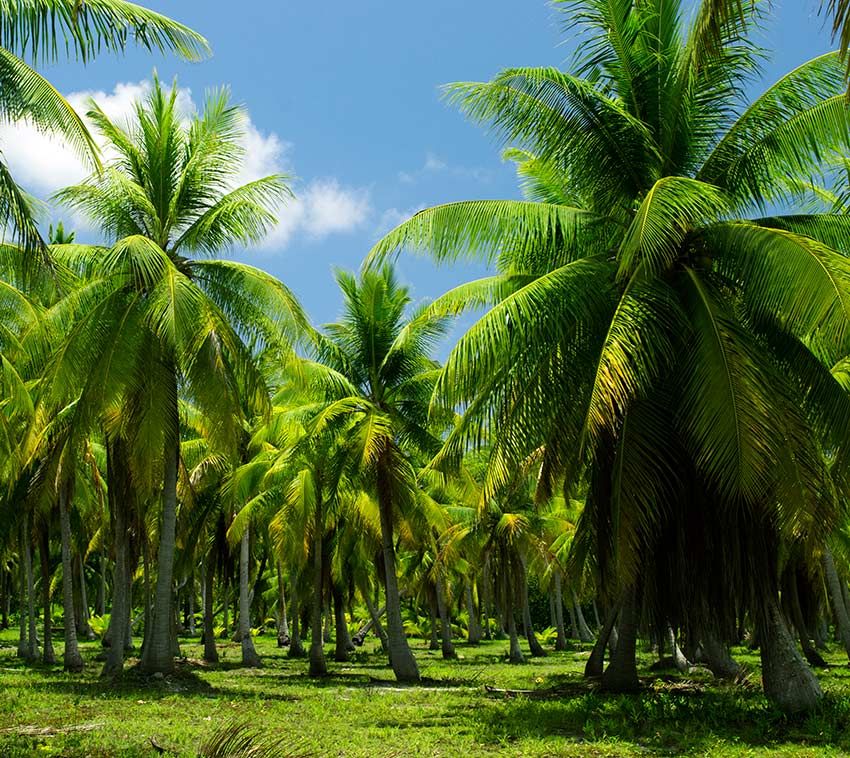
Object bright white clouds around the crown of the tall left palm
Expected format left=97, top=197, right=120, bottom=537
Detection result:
left=0, top=81, right=371, bottom=250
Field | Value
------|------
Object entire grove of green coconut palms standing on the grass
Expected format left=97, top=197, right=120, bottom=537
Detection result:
left=0, top=0, right=850, bottom=724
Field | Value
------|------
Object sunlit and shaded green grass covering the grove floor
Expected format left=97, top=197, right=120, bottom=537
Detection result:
left=0, top=631, right=850, bottom=758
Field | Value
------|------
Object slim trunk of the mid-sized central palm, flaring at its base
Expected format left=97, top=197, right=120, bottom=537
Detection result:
left=378, top=453, right=419, bottom=682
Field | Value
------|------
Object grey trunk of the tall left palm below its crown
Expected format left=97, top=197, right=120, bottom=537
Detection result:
left=140, top=392, right=180, bottom=674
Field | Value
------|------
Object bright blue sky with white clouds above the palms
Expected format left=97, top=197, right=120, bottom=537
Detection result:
left=0, top=0, right=831, bottom=342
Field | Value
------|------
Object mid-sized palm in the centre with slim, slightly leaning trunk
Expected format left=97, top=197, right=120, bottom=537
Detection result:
left=304, top=268, right=444, bottom=681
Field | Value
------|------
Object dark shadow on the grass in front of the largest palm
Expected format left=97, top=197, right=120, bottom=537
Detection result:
left=470, top=680, right=850, bottom=755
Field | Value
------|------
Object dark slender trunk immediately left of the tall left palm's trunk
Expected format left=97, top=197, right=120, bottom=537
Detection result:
left=101, top=438, right=132, bottom=676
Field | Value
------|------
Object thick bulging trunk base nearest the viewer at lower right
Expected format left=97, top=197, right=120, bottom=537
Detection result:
left=758, top=594, right=823, bottom=713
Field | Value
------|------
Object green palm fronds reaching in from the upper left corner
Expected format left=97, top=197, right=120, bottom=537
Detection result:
left=0, top=0, right=209, bottom=251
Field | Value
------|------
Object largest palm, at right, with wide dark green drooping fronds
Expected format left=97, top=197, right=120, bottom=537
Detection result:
left=372, top=0, right=850, bottom=710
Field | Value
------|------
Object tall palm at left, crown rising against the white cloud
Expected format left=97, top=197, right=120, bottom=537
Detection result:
left=41, top=79, right=304, bottom=671
